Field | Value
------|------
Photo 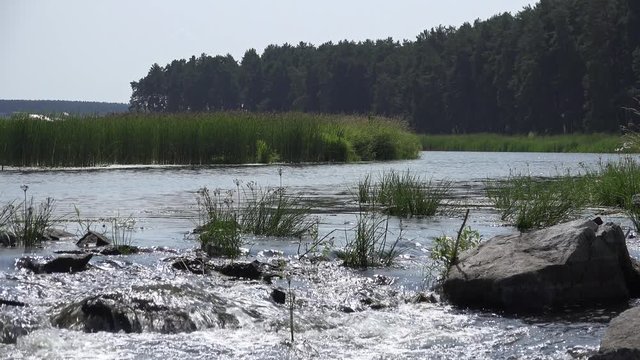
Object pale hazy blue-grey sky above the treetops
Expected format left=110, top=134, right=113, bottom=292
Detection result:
left=0, top=0, right=536, bottom=103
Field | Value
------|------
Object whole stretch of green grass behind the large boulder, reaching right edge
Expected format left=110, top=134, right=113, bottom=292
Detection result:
left=487, top=155, right=640, bottom=230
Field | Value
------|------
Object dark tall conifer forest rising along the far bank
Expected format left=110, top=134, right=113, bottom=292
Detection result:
left=130, top=0, right=640, bottom=134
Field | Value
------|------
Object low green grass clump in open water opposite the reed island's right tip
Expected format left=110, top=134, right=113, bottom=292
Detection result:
left=358, top=170, right=451, bottom=217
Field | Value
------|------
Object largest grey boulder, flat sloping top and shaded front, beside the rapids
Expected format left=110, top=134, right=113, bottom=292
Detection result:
left=443, top=219, right=640, bottom=313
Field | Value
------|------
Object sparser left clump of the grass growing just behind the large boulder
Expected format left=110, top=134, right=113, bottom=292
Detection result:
left=486, top=174, right=589, bottom=231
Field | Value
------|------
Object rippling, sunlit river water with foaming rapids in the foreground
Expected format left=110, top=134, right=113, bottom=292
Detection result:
left=0, top=152, right=640, bottom=359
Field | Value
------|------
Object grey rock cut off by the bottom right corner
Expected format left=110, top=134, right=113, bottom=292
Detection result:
left=589, top=307, right=640, bottom=360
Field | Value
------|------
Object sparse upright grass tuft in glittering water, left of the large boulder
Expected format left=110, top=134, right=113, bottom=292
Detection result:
left=339, top=210, right=402, bottom=269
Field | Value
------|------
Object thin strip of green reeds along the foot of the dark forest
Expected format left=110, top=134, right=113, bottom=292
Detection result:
left=420, top=133, right=622, bottom=153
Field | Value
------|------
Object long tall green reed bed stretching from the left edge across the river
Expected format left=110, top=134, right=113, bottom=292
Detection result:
left=0, top=112, right=420, bottom=167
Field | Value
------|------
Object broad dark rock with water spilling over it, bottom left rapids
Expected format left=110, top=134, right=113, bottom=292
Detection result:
left=51, top=291, right=238, bottom=334
